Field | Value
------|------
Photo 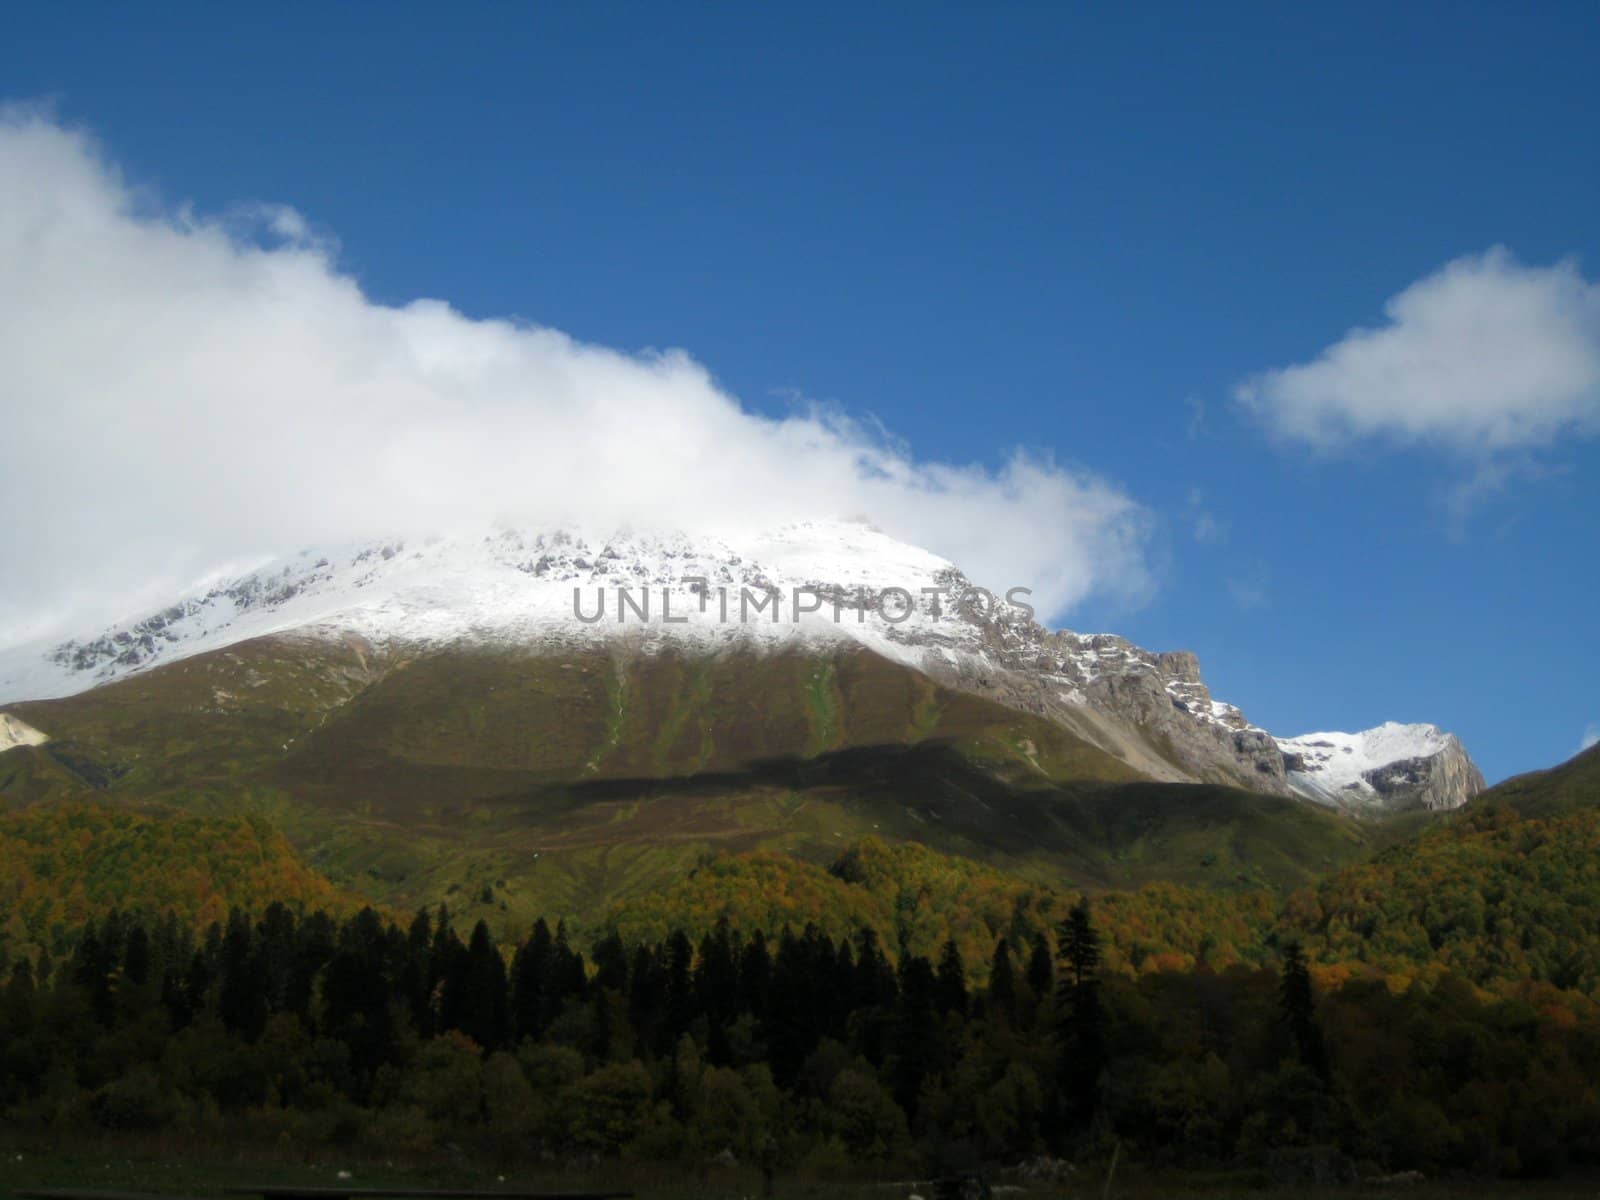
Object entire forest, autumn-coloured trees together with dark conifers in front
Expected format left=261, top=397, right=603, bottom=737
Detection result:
left=0, top=755, right=1600, bottom=1186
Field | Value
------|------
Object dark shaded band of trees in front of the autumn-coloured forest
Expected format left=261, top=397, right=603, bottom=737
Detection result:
left=0, top=904, right=1600, bottom=1174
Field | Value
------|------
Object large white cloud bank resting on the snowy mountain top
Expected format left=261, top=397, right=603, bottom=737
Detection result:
left=0, top=109, right=1149, bottom=645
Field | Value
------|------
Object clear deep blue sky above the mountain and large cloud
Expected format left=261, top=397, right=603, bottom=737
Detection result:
left=0, top=3, right=1600, bottom=779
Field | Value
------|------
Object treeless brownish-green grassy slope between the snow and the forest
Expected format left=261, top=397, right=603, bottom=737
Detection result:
left=0, top=638, right=1376, bottom=928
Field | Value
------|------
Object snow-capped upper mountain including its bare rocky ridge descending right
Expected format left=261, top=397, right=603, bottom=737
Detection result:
left=0, top=522, right=1483, bottom=808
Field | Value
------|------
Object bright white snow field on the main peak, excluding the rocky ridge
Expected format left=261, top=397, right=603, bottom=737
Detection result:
left=0, top=523, right=968, bottom=702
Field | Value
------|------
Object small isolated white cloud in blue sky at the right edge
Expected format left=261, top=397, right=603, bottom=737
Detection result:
left=1237, top=246, right=1600, bottom=459
